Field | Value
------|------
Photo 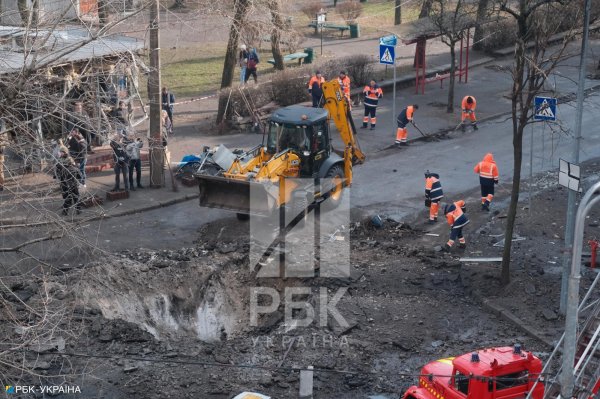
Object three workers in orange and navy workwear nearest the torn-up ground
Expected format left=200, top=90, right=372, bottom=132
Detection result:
left=425, top=153, right=498, bottom=251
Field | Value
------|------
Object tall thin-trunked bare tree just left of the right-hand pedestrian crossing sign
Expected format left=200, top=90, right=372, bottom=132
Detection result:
left=499, top=0, right=574, bottom=284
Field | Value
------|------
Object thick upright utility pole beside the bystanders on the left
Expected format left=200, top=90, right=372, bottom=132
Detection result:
left=148, top=0, right=165, bottom=188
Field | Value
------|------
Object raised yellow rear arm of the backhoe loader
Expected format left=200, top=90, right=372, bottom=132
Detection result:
left=323, top=79, right=365, bottom=169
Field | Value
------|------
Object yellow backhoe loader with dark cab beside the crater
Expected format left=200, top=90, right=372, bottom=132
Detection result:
left=195, top=79, right=365, bottom=219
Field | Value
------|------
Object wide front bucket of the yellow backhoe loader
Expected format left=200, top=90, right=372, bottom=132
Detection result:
left=196, top=175, right=278, bottom=216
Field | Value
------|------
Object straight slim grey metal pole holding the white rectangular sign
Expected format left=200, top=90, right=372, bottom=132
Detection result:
left=560, top=0, right=591, bottom=315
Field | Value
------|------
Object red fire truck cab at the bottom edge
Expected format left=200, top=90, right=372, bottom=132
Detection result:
left=403, top=344, right=544, bottom=399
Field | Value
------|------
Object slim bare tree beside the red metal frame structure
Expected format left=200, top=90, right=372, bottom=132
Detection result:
left=429, top=0, right=475, bottom=113
